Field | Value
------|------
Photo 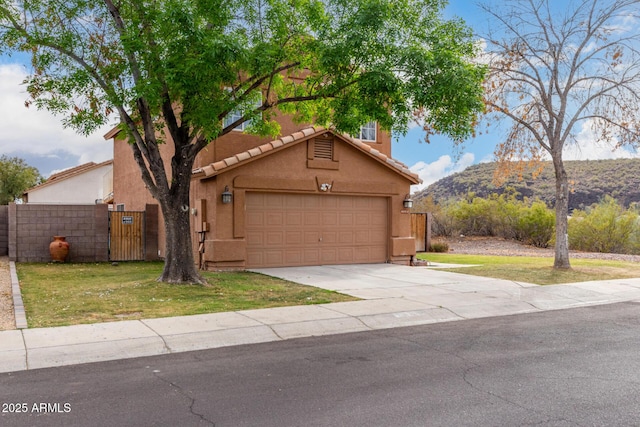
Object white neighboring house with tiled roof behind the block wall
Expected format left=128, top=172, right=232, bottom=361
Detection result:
left=23, top=160, right=113, bottom=205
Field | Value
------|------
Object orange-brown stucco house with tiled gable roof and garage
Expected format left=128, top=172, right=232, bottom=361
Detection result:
left=105, top=117, right=420, bottom=269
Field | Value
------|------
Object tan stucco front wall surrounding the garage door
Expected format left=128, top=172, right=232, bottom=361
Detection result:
left=192, top=137, right=415, bottom=268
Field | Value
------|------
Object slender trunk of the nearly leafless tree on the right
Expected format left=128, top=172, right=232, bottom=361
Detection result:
left=552, top=153, right=571, bottom=269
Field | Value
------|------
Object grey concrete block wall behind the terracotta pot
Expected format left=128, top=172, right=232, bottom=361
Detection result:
left=8, top=204, right=109, bottom=262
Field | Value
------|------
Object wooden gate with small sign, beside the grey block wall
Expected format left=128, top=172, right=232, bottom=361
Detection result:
left=109, top=211, right=144, bottom=261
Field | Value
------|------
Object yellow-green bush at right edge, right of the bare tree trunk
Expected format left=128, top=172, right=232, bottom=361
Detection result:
left=569, top=196, right=640, bottom=253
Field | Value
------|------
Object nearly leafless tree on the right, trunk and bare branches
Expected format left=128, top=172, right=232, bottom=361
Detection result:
left=481, top=0, right=640, bottom=269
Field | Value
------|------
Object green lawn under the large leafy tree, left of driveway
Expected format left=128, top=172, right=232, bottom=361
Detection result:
left=17, top=262, right=357, bottom=328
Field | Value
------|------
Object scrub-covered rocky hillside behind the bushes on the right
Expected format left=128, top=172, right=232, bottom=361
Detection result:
left=414, top=159, right=640, bottom=210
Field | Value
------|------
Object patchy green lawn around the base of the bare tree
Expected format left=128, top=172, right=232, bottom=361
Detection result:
left=418, top=253, right=640, bottom=285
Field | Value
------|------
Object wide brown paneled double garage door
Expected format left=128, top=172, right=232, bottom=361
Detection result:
left=246, top=193, right=388, bottom=267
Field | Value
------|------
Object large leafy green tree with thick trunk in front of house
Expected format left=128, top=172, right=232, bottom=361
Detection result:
left=0, top=0, right=485, bottom=282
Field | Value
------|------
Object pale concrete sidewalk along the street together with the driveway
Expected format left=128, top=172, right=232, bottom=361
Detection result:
left=0, top=264, right=640, bottom=372
